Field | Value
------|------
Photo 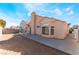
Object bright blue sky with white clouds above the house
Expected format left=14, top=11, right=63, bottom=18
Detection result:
left=0, top=3, right=79, bottom=27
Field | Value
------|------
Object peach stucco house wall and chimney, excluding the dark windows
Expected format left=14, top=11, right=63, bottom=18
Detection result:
left=30, top=14, right=69, bottom=39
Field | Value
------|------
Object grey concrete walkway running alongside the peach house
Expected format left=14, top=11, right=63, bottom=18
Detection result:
left=22, top=34, right=79, bottom=55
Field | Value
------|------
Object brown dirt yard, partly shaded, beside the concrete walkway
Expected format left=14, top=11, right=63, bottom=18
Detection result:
left=0, top=34, right=66, bottom=55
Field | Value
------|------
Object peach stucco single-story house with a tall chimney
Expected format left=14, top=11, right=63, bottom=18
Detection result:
left=29, top=12, right=69, bottom=39
